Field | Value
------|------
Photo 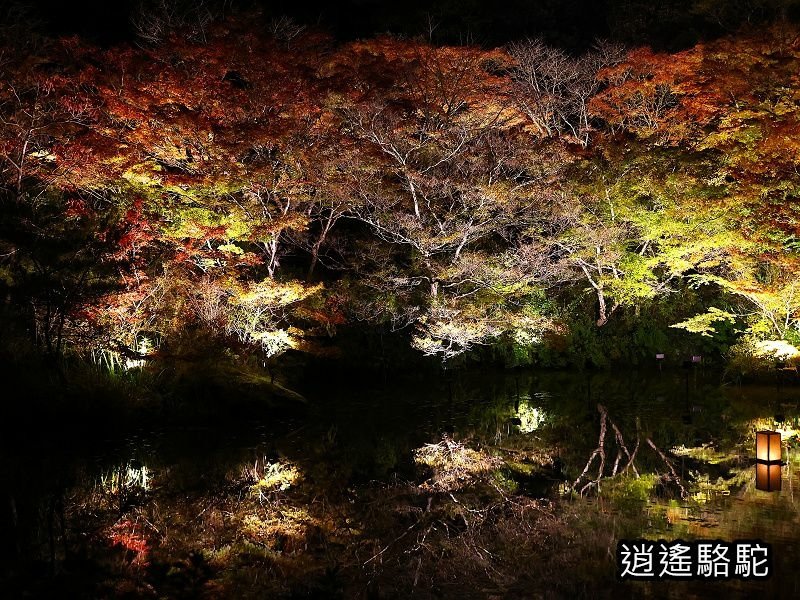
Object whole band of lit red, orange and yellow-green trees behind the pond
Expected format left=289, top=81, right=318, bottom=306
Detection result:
left=0, top=2, right=800, bottom=376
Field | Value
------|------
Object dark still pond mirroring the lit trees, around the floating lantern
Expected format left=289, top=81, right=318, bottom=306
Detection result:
left=0, top=369, right=800, bottom=598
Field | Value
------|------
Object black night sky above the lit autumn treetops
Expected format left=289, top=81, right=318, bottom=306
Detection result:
left=9, top=0, right=800, bottom=50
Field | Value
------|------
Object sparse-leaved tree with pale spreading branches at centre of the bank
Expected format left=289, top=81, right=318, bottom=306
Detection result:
left=322, top=40, right=560, bottom=358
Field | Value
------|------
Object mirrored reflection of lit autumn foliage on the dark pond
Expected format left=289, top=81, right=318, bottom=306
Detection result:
left=18, top=372, right=798, bottom=597
